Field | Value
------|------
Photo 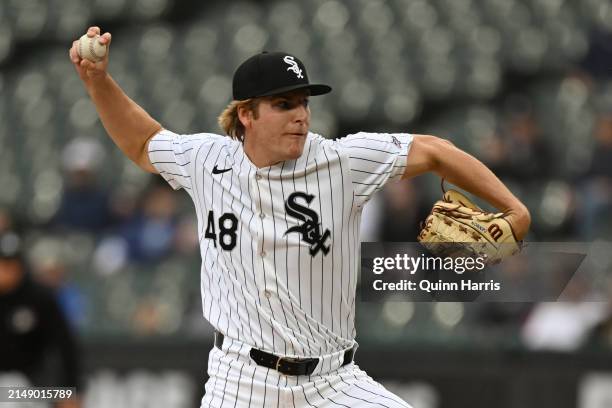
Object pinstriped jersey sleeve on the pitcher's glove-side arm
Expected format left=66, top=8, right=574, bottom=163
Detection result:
left=338, top=132, right=412, bottom=206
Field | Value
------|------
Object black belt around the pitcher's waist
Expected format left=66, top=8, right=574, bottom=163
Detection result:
left=215, top=331, right=357, bottom=375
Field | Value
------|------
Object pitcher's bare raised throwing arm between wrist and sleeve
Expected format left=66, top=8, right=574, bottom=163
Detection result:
left=86, top=74, right=162, bottom=167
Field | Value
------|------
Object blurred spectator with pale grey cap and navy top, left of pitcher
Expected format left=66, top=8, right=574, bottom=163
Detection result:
left=52, top=138, right=113, bottom=233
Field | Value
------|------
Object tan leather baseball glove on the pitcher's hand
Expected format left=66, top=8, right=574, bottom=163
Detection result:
left=417, top=189, right=522, bottom=264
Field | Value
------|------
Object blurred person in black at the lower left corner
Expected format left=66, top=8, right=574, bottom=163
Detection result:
left=0, top=232, right=80, bottom=406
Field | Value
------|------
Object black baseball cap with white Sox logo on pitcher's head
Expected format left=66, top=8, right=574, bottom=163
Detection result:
left=232, top=51, right=331, bottom=101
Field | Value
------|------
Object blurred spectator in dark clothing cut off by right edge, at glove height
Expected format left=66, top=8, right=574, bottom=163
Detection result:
left=578, top=114, right=612, bottom=240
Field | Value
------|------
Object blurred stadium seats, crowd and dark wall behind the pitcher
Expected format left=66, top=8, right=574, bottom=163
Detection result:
left=0, top=0, right=612, bottom=408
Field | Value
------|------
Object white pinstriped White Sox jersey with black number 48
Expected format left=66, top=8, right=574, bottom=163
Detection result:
left=149, top=130, right=412, bottom=357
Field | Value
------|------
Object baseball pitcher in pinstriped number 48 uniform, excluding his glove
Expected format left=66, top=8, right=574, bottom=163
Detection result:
left=70, top=27, right=530, bottom=408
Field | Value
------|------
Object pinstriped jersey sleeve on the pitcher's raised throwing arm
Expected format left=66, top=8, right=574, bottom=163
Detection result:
left=149, top=129, right=206, bottom=190
